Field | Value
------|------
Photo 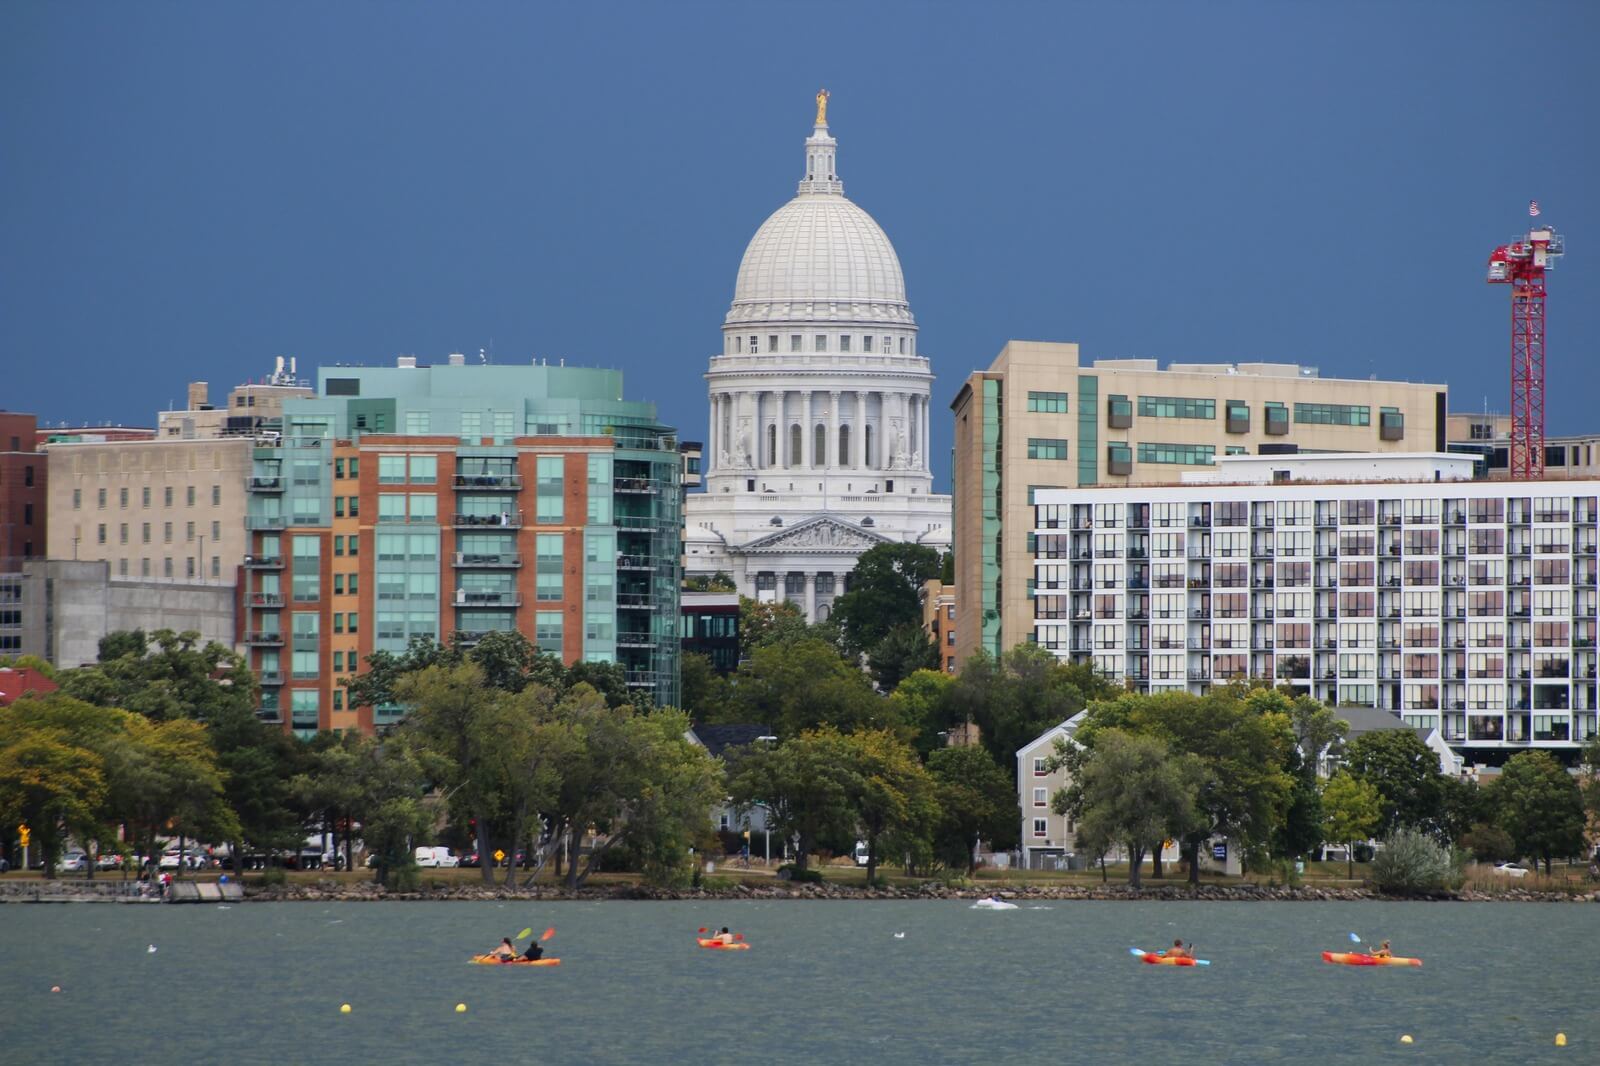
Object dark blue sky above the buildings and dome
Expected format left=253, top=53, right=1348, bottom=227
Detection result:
left=0, top=0, right=1600, bottom=477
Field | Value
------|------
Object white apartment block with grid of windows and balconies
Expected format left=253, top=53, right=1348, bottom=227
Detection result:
left=1029, top=453, right=1600, bottom=763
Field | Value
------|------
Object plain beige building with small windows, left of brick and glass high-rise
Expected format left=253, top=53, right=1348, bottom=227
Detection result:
left=48, top=437, right=254, bottom=584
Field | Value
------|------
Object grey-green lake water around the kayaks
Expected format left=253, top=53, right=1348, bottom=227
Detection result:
left=0, top=901, right=1600, bottom=1066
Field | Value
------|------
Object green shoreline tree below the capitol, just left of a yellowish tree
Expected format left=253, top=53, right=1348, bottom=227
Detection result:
left=728, top=728, right=861, bottom=869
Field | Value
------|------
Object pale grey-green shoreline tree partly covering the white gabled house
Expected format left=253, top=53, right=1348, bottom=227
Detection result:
left=1051, top=728, right=1206, bottom=888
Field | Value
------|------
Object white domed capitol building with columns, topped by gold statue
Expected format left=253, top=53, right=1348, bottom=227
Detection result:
left=685, top=93, right=950, bottom=621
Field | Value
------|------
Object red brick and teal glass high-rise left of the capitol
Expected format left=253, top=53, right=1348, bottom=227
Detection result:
left=245, top=357, right=682, bottom=731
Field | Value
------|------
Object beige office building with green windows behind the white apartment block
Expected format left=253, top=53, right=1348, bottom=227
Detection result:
left=950, top=341, right=1446, bottom=666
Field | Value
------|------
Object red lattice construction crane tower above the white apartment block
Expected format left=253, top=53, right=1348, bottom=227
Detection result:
left=1488, top=202, right=1565, bottom=479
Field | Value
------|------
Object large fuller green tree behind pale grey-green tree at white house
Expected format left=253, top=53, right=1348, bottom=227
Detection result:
left=1077, top=685, right=1294, bottom=884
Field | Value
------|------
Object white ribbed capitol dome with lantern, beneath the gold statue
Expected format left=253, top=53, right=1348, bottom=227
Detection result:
left=725, top=104, right=915, bottom=328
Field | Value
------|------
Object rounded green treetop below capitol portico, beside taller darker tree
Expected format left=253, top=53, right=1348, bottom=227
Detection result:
left=731, top=640, right=894, bottom=736
